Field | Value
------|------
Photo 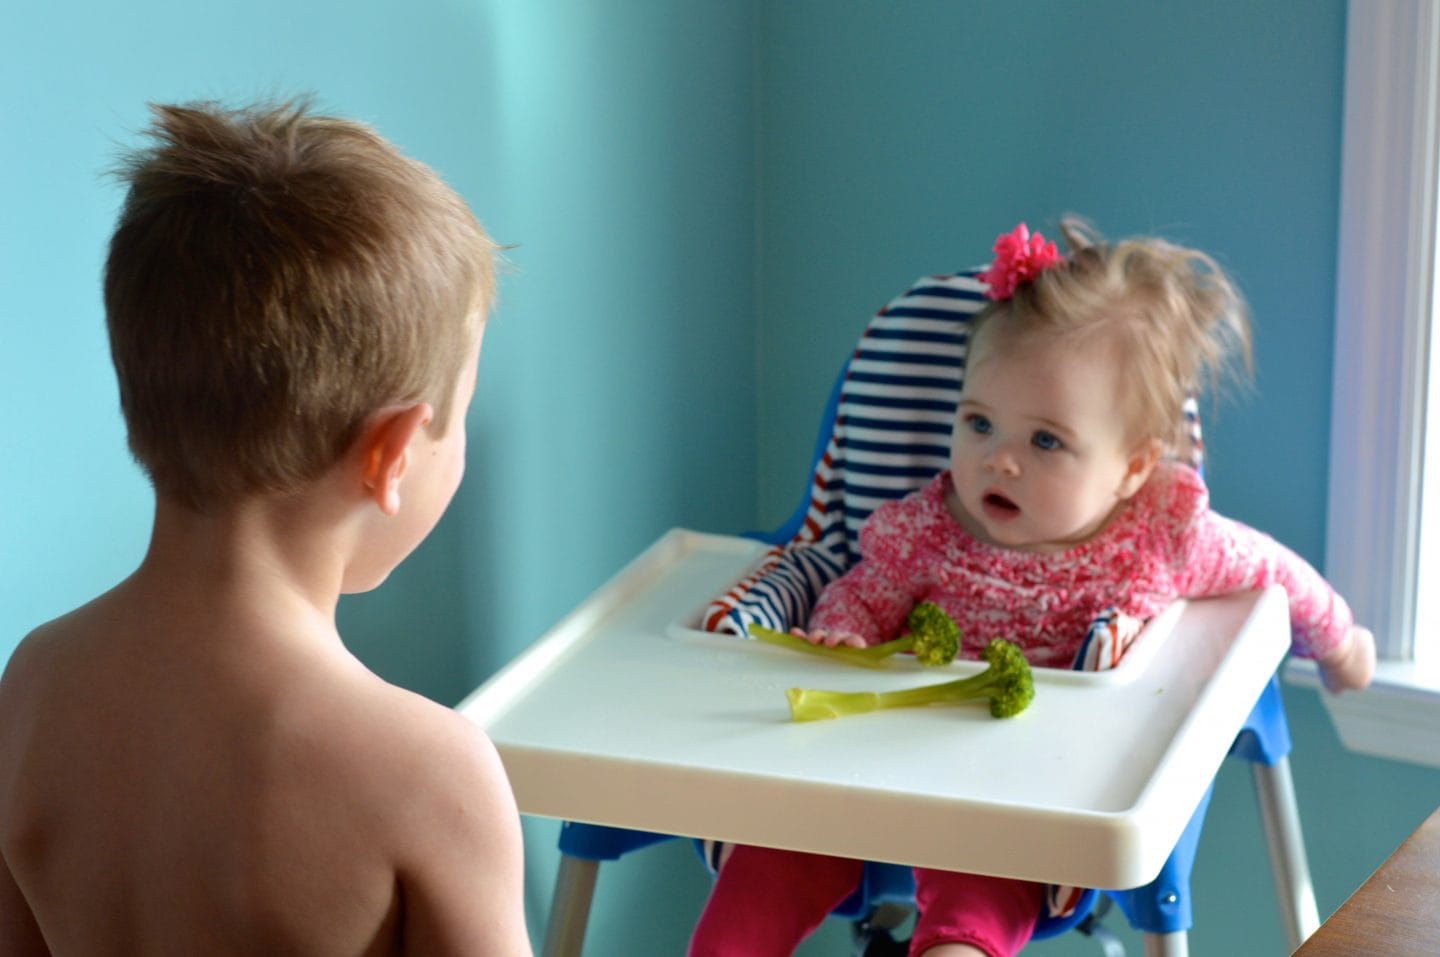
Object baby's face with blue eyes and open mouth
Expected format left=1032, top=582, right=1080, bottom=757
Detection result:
left=949, top=327, right=1148, bottom=551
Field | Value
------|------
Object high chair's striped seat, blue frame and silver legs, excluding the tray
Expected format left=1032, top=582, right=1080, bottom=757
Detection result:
left=515, top=271, right=1319, bottom=957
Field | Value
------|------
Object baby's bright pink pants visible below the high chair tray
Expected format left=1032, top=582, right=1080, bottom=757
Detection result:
left=688, top=845, right=1044, bottom=957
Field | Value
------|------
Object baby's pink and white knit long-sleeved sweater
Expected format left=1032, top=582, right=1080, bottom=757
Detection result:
left=809, top=465, right=1352, bottom=668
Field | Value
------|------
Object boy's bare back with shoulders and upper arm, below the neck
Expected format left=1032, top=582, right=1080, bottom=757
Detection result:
left=0, top=564, right=528, bottom=956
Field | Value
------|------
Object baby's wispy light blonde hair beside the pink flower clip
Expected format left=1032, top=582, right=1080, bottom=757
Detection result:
left=971, top=216, right=1251, bottom=455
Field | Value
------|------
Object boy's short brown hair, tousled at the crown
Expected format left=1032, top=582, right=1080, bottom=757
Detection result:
left=105, top=102, right=495, bottom=511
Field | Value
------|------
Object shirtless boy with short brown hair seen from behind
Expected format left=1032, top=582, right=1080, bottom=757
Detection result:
left=0, top=104, right=530, bottom=957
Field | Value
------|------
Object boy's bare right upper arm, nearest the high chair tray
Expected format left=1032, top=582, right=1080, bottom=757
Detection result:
left=399, top=714, right=531, bottom=957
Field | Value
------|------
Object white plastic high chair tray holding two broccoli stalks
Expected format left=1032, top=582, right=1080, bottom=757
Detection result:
left=459, top=530, right=1290, bottom=888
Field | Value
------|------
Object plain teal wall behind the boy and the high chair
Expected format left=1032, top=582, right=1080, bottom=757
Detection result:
left=0, top=0, right=1440, bottom=954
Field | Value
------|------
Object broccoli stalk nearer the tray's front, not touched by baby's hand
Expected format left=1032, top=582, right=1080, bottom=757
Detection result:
left=785, top=638, right=1035, bottom=721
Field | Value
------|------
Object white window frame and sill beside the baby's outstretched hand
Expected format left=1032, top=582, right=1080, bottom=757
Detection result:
left=1289, top=0, right=1440, bottom=767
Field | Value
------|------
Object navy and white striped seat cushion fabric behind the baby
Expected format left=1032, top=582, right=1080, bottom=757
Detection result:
left=704, top=268, right=1202, bottom=635
